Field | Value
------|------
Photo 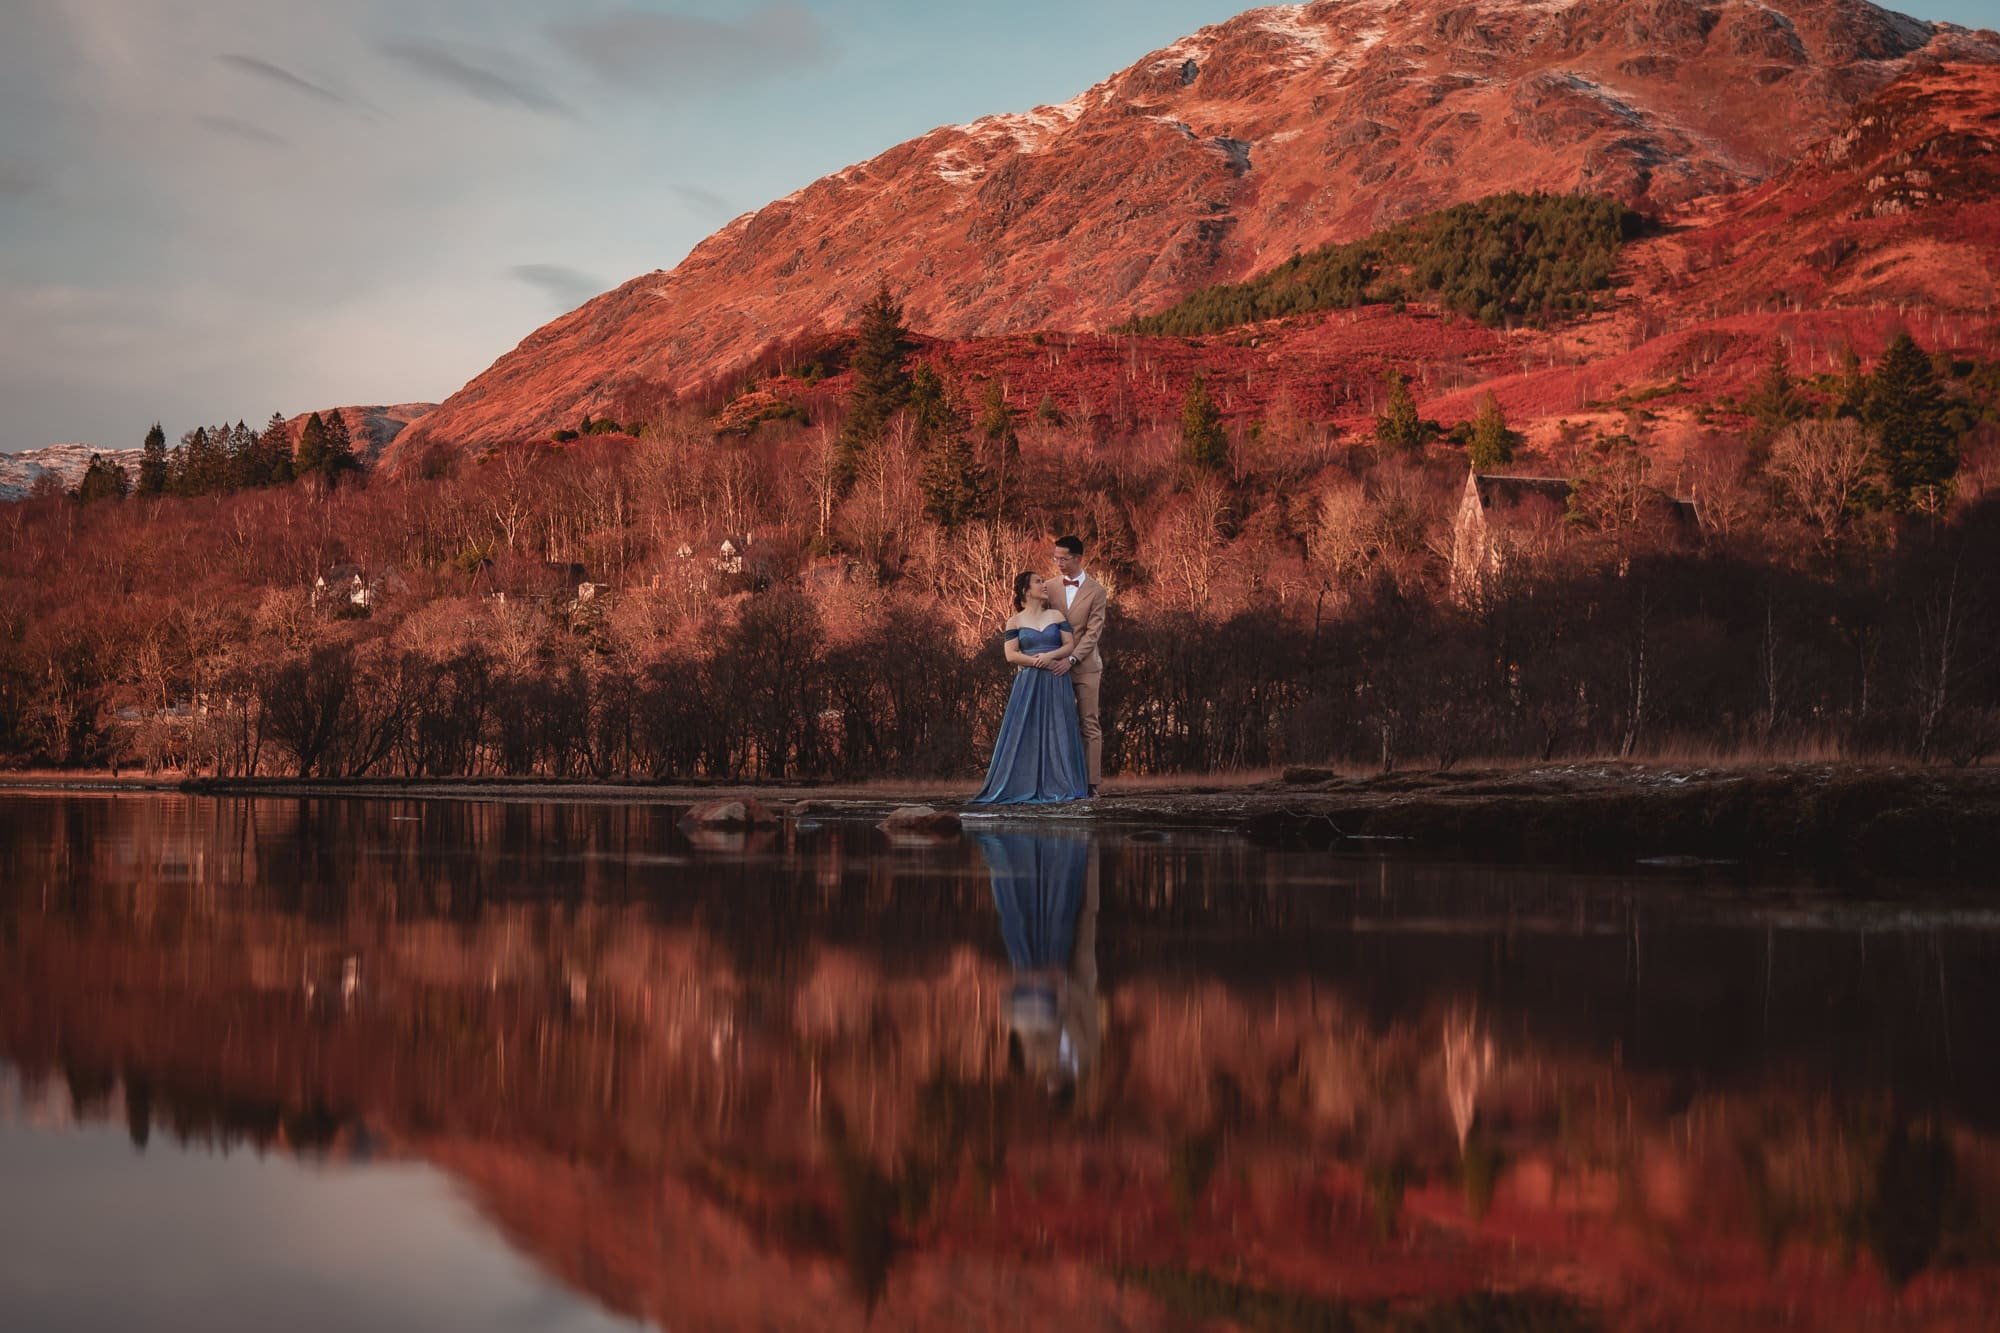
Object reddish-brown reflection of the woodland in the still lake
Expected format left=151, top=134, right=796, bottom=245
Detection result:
left=0, top=788, right=2000, bottom=1305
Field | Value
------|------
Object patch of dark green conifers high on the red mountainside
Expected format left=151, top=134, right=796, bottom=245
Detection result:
left=1122, top=194, right=1642, bottom=336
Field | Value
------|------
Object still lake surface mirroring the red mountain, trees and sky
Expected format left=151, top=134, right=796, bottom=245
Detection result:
left=0, top=795, right=2000, bottom=1329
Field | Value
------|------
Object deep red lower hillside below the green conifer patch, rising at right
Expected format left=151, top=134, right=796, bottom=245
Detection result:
left=484, top=64, right=2000, bottom=462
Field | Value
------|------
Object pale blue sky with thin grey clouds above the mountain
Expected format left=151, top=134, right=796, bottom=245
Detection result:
left=0, top=0, right=1994, bottom=450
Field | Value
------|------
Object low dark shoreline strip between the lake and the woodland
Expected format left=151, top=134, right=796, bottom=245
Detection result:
left=0, top=763, right=2000, bottom=885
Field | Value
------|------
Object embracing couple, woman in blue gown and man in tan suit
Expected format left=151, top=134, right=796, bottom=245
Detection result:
left=972, top=536, right=1108, bottom=805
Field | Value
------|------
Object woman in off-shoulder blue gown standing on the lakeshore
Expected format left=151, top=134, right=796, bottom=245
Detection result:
left=972, top=572, right=1090, bottom=805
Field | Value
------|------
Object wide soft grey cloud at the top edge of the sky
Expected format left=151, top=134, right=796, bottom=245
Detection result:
left=550, top=0, right=828, bottom=90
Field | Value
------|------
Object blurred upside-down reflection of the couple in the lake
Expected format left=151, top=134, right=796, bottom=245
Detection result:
left=972, top=831, right=1104, bottom=1097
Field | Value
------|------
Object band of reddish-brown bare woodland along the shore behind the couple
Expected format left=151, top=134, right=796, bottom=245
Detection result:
left=0, top=280, right=2000, bottom=783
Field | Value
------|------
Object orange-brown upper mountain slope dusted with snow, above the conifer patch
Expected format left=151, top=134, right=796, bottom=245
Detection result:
left=384, top=0, right=2000, bottom=470
